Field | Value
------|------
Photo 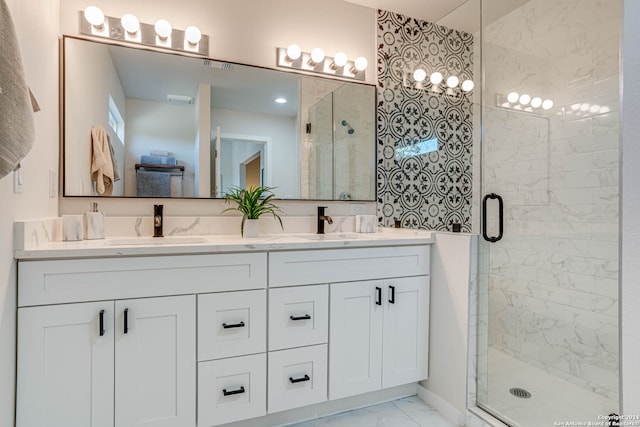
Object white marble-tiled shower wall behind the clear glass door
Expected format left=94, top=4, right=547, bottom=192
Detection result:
left=480, top=0, right=622, bottom=399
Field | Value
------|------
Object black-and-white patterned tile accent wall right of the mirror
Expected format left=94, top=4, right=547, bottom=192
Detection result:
left=377, top=10, right=479, bottom=232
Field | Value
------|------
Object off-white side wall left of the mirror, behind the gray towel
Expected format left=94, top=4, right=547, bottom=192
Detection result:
left=0, top=0, right=59, bottom=427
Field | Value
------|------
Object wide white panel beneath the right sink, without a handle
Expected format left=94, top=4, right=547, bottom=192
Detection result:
left=269, top=245, right=429, bottom=287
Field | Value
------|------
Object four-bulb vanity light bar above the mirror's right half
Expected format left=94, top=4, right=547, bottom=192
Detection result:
left=276, top=44, right=369, bottom=80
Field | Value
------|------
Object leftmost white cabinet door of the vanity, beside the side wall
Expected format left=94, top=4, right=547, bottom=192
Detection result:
left=16, top=301, right=114, bottom=427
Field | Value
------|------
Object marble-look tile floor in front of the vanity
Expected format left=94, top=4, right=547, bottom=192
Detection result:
left=291, top=396, right=456, bottom=427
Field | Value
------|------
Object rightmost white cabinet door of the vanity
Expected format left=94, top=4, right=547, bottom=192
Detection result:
left=382, top=276, right=429, bottom=388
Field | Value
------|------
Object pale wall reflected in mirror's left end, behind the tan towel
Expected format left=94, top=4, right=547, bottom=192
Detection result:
left=64, top=40, right=126, bottom=196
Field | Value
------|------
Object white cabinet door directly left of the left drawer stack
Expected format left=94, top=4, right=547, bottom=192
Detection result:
left=115, top=295, right=196, bottom=427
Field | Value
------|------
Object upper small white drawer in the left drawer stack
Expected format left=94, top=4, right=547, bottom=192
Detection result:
left=198, top=290, right=267, bottom=361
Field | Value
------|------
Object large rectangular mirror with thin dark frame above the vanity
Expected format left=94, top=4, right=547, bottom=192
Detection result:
left=63, top=36, right=376, bottom=201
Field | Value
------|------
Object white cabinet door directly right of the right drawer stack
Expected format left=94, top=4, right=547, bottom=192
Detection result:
left=329, top=281, right=382, bottom=399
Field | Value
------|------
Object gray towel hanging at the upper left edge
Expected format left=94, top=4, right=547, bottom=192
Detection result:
left=0, top=0, right=35, bottom=178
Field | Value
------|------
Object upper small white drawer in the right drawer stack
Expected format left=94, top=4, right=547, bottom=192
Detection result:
left=269, top=285, right=329, bottom=350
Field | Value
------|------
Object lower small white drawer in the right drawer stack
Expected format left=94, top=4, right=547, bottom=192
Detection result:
left=268, top=344, right=327, bottom=413
